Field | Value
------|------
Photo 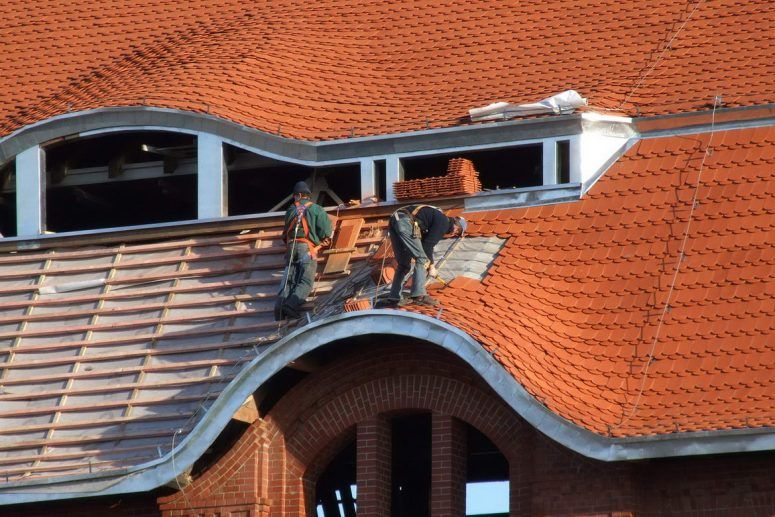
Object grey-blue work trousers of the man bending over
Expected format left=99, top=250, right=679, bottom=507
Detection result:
left=388, top=212, right=428, bottom=300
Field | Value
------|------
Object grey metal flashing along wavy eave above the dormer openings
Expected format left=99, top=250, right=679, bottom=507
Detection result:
left=0, top=107, right=582, bottom=165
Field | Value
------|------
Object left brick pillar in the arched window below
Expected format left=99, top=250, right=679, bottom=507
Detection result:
left=356, top=415, right=392, bottom=517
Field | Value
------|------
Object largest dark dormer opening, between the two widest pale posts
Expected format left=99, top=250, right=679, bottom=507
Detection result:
left=44, top=131, right=197, bottom=233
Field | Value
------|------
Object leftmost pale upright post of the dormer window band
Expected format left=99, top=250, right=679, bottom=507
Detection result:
left=16, top=145, right=46, bottom=237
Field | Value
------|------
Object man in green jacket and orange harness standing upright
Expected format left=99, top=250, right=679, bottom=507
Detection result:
left=274, top=181, right=331, bottom=321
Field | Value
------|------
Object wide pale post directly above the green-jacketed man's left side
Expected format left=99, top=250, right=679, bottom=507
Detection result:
left=197, top=133, right=229, bottom=219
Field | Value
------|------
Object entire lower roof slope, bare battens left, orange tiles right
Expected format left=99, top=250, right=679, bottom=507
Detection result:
left=0, top=128, right=775, bottom=480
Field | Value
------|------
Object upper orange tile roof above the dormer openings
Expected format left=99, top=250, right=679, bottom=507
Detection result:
left=0, top=0, right=775, bottom=140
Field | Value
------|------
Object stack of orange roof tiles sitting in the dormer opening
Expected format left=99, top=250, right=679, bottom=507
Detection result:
left=393, top=158, right=482, bottom=199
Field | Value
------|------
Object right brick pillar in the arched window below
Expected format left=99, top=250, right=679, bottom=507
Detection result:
left=431, top=413, right=468, bottom=517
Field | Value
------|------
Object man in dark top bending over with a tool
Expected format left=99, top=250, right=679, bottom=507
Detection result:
left=380, top=205, right=467, bottom=307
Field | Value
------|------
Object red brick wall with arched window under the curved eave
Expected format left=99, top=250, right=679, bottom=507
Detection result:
left=153, top=344, right=775, bottom=517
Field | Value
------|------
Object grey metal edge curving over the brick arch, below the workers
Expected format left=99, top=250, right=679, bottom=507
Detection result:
left=0, top=310, right=775, bottom=504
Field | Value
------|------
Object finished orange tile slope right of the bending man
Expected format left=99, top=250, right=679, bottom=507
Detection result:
left=418, top=127, right=775, bottom=437
